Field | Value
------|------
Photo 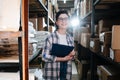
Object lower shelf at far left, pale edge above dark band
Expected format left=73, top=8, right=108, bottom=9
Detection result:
left=0, top=55, right=19, bottom=72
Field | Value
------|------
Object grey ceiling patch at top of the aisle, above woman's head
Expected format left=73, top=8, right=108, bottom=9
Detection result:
left=57, top=0, right=75, bottom=10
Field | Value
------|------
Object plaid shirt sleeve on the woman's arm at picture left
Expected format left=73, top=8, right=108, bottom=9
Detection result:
left=42, top=37, right=56, bottom=62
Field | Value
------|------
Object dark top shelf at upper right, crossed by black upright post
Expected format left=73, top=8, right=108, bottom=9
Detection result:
left=81, top=0, right=120, bottom=24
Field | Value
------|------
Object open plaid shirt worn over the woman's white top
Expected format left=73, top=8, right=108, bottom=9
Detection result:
left=42, top=32, right=74, bottom=80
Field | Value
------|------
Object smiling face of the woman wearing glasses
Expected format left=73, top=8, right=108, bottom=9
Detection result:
left=56, top=14, right=69, bottom=29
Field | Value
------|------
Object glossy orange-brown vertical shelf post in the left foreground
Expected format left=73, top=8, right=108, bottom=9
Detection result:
left=21, top=0, right=29, bottom=80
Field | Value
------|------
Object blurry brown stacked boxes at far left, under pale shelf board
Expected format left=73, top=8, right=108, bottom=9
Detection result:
left=0, top=38, right=18, bottom=55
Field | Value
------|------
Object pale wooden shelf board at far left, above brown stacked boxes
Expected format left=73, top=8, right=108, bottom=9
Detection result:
left=0, top=31, right=22, bottom=39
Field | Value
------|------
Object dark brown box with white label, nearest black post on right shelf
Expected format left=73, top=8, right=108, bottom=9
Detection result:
left=90, top=38, right=101, bottom=53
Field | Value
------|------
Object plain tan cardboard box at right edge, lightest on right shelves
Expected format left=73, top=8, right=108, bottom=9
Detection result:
left=112, top=25, right=120, bottom=49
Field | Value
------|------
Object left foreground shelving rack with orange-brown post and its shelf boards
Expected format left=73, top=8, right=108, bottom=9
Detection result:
left=0, top=0, right=29, bottom=80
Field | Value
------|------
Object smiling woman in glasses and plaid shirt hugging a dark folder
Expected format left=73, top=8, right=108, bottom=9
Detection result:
left=42, top=10, right=75, bottom=80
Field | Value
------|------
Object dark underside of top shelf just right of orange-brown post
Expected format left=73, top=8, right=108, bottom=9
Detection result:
left=29, top=0, right=48, bottom=18
